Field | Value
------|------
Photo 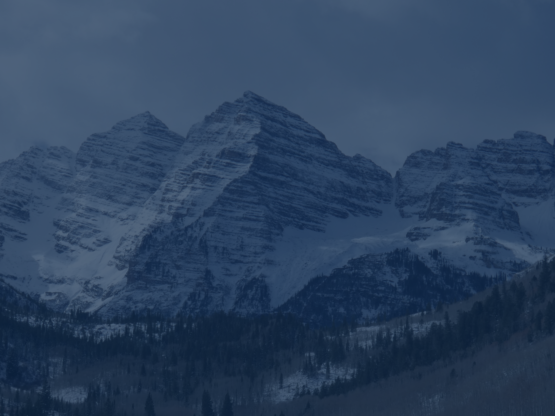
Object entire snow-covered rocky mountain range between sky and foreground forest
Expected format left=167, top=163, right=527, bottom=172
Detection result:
left=0, top=92, right=555, bottom=318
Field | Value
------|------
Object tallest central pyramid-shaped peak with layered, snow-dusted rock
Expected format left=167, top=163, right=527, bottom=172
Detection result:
left=106, top=93, right=392, bottom=313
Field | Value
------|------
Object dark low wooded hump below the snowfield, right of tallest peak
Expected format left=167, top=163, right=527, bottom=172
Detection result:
left=279, top=248, right=505, bottom=326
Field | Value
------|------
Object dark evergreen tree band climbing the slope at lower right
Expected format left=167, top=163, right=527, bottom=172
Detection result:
left=314, top=259, right=555, bottom=397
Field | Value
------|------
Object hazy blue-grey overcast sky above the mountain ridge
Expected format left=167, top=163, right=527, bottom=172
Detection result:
left=0, top=0, right=555, bottom=173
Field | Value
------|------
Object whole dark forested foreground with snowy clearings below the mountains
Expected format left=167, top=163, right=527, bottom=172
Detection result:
left=0, top=259, right=555, bottom=416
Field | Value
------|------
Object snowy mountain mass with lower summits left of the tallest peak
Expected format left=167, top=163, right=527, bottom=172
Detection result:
left=0, top=113, right=188, bottom=309
